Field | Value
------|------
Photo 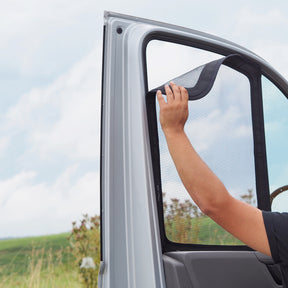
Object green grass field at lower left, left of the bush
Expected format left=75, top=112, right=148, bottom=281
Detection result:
left=0, top=233, right=81, bottom=288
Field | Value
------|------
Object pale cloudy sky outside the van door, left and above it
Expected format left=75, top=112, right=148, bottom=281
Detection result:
left=0, top=0, right=288, bottom=238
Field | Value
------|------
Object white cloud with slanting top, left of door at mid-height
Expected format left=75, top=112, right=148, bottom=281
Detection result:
left=2, top=47, right=101, bottom=159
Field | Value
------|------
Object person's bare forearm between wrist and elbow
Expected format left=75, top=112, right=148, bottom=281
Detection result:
left=164, top=131, right=231, bottom=215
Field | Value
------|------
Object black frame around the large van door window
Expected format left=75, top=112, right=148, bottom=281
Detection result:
left=142, top=31, right=276, bottom=253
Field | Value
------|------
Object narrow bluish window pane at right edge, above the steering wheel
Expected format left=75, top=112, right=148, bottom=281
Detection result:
left=262, top=76, right=288, bottom=212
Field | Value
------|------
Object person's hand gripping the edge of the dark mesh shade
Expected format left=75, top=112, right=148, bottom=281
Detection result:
left=157, top=82, right=188, bottom=136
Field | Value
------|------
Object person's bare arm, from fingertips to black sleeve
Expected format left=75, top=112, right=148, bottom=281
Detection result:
left=157, top=83, right=271, bottom=256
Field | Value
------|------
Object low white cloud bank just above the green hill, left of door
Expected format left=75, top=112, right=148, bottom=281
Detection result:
left=0, top=166, right=100, bottom=238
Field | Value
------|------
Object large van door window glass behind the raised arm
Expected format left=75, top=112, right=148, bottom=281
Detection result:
left=147, top=41, right=257, bottom=245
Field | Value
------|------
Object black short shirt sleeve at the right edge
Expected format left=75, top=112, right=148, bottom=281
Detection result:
left=262, top=211, right=288, bottom=288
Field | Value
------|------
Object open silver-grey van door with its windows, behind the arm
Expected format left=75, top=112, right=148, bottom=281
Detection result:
left=98, top=12, right=288, bottom=288
